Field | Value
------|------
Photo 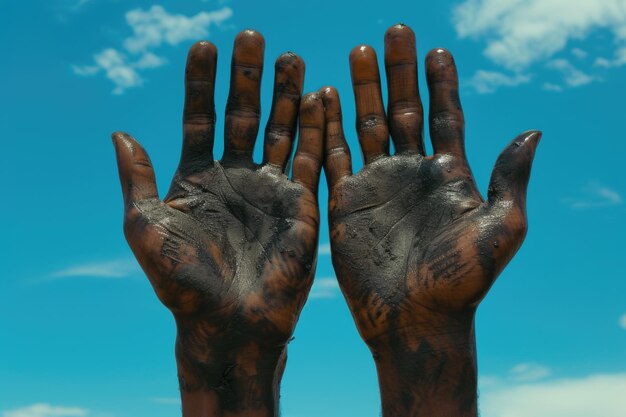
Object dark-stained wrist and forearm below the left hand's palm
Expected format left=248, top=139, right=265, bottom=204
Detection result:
left=176, top=334, right=287, bottom=417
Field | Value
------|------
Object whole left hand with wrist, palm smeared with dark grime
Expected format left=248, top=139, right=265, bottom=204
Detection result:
left=113, top=30, right=324, bottom=417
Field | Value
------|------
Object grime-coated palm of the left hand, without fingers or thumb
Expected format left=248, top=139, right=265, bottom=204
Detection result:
left=164, top=163, right=319, bottom=315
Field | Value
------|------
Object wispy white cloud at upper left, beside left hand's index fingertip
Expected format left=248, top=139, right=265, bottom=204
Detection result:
left=72, top=5, right=233, bottom=94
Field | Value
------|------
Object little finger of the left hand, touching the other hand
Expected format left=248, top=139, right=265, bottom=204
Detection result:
left=293, top=93, right=324, bottom=195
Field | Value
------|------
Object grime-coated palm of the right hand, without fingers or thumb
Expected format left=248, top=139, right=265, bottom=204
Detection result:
left=330, top=156, right=510, bottom=339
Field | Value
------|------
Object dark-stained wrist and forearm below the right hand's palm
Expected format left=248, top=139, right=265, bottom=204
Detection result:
left=372, top=316, right=478, bottom=417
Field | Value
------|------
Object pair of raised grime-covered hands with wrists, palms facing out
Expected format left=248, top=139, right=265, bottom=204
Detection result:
left=113, top=24, right=541, bottom=417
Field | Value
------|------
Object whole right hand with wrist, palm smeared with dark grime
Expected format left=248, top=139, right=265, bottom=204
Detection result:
left=320, top=25, right=541, bottom=417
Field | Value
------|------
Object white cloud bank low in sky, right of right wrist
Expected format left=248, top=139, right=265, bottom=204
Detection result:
left=480, top=374, right=626, bottom=417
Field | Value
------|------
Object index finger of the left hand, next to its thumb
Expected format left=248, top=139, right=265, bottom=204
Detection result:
left=178, top=41, right=217, bottom=176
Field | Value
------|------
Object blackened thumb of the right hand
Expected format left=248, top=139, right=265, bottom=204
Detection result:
left=488, top=130, right=541, bottom=209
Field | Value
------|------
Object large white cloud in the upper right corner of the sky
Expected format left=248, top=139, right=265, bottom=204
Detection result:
left=452, top=0, right=626, bottom=93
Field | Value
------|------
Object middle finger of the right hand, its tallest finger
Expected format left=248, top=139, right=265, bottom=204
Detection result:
left=385, top=24, right=425, bottom=155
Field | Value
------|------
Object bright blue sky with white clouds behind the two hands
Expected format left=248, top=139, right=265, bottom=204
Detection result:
left=0, top=0, right=626, bottom=417
